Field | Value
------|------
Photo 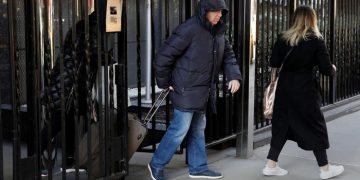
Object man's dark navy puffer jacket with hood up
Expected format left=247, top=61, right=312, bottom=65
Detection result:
left=154, top=0, right=241, bottom=111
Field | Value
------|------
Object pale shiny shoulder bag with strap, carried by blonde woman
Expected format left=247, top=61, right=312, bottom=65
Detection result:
left=263, top=48, right=293, bottom=119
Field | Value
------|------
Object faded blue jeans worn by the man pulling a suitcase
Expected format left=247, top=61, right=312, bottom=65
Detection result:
left=151, top=109, right=208, bottom=173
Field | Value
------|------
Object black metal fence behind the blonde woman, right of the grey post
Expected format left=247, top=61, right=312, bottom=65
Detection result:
left=255, top=0, right=360, bottom=129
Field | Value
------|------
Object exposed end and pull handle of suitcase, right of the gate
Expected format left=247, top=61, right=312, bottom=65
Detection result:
left=128, top=89, right=170, bottom=160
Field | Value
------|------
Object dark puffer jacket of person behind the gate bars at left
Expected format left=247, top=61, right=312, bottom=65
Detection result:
left=50, top=12, right=98, bottom=112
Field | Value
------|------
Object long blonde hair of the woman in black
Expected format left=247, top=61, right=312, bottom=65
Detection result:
left=282, top=6, right=322, bottom=46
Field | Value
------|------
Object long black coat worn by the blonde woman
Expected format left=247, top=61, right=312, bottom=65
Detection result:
left=270, top=34, right=335, bottom=150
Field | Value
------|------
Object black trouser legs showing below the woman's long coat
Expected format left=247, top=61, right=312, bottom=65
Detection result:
left=267, top=142, right=328, bottom=167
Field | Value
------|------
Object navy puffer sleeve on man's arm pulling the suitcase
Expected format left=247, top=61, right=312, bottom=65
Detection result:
left=153, top=24, right=192, bottom=89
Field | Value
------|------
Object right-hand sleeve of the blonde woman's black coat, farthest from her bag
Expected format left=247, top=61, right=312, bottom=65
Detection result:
left=315, top=39, right=335, bottom=76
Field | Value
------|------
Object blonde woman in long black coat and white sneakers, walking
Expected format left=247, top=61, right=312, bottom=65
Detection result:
left=263, top=6, right=344, bottom=179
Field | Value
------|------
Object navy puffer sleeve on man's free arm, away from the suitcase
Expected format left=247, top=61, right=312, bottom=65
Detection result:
left=223, top=38, right=242, bottom=81
